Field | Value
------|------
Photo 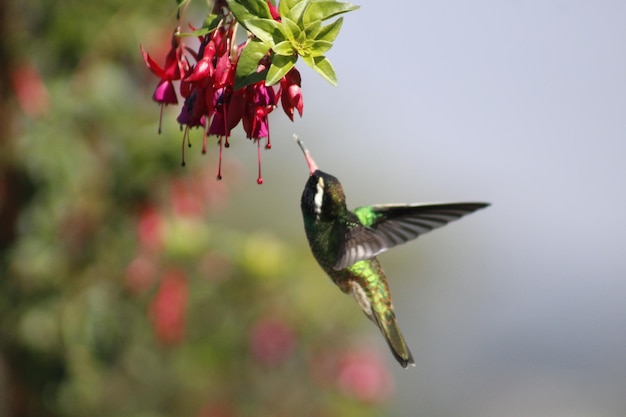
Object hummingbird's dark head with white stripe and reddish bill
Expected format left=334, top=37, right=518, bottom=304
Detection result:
left=294, top=135, right=347, bottom=220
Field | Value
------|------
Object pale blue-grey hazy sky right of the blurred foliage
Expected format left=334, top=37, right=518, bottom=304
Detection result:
left=222, top=0, right=626, bottom=417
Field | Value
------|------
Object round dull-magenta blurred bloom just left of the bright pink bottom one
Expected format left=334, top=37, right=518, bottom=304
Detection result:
left=250, top=318, right=296, bottom=365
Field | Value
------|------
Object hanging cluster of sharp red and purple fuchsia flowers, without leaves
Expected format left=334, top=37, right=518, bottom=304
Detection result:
left=141, top=7, right=303, bottom=184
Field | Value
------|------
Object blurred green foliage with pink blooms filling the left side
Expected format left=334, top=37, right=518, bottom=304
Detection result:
left=0, top=0, right=392, bottom=417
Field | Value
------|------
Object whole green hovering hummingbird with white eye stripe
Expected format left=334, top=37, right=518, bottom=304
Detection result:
left=294, top=135, right=489, bottom=368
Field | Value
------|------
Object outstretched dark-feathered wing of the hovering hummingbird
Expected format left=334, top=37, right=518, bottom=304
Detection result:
left=333, top=203, right=489, bottom=270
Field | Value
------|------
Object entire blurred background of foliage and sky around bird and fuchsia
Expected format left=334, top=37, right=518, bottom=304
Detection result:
left=0, top=0, right=626, bottom=417
